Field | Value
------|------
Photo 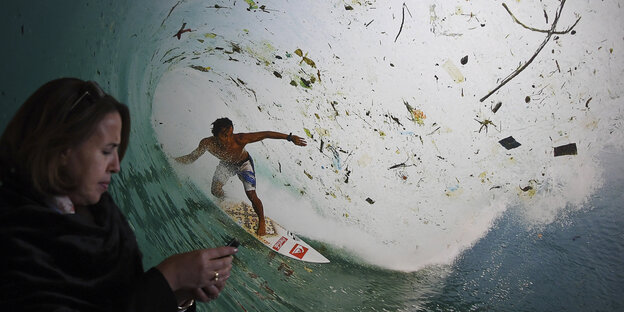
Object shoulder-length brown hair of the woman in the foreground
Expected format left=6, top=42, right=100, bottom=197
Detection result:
left=0, top=78, right=130, bottom=196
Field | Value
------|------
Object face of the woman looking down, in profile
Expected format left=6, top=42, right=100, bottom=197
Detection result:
left=63, top=112, right=121, bottom=206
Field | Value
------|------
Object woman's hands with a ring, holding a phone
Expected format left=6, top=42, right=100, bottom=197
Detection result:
left=156, top=247, right=238, bottom=303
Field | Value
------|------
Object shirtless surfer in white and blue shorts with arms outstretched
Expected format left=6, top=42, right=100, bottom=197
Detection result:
left=175, top=118, right=306, bottom=236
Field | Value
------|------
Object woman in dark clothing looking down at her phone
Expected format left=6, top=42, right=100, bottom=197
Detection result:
left=0, top=78, right=237, bottom=311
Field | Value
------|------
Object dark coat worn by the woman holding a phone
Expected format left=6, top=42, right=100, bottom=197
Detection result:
left=0, top=184, right=190, bottom=312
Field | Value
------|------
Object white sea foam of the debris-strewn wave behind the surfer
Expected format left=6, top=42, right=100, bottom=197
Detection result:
left=153, top=1, right=624, bottom=271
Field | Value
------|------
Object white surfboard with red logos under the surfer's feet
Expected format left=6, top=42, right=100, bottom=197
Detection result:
left=220, top=202, right=329, bottom=263
